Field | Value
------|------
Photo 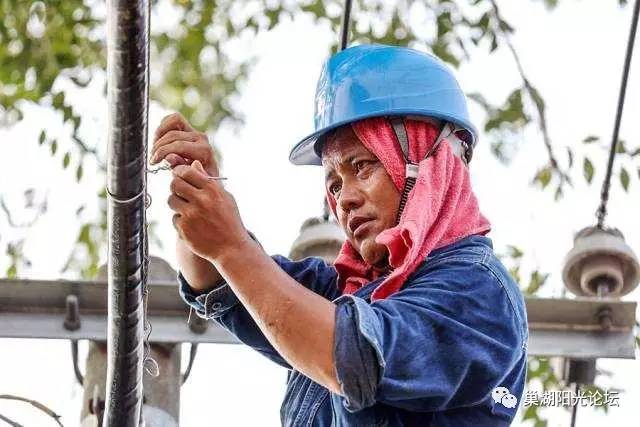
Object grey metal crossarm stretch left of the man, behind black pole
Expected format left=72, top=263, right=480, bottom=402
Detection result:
left=0, top=279, right=238, bottom=344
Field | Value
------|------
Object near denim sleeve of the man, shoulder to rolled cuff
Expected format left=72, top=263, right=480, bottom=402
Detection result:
left=334, top=265, right=524, bottom=412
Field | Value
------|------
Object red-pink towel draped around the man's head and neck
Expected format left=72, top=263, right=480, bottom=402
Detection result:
left=327, top=118, right=491, bottom=301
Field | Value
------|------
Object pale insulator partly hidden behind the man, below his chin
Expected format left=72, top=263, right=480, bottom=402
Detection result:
left=289, top=218, right=344, bottom=264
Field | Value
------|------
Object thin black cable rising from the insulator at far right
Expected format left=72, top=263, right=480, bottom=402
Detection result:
left=596, top=0, right=640, bottom=229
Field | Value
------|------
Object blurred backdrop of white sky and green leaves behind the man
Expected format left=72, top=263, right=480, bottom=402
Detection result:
left=0, top=0, right=640, bottom=427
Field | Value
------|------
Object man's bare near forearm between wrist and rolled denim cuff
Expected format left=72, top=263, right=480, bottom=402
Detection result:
left=212, top=237, right=340, bottom=393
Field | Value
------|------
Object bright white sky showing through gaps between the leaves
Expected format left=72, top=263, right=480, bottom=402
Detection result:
left=0, top=0, right=640, bottom=427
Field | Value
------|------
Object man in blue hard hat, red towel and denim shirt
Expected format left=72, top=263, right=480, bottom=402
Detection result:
left=151, top=45, right=528, bottom=427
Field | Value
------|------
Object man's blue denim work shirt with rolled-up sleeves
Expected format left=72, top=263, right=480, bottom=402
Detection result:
left=178, top=236, right=528, bottom=427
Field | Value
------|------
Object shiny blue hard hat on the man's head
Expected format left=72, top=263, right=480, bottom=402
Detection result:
left=289, top=45, right=478, bottom=165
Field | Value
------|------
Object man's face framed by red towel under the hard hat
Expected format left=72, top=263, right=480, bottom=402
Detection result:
left=322, top=126, right=400, bottom=267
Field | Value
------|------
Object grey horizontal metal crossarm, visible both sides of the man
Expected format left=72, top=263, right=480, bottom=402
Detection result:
left=0, top=280, right=637, bottom=359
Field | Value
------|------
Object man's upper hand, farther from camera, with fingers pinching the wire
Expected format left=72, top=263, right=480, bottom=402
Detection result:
left=150, top=113, right=219, bottom=176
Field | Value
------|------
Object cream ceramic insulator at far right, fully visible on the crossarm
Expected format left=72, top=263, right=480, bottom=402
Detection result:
left=562, top=227, right=640, bottom=297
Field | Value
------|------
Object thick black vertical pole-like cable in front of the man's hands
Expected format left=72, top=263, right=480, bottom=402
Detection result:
left=103, top=0, right=149, bottom=426
